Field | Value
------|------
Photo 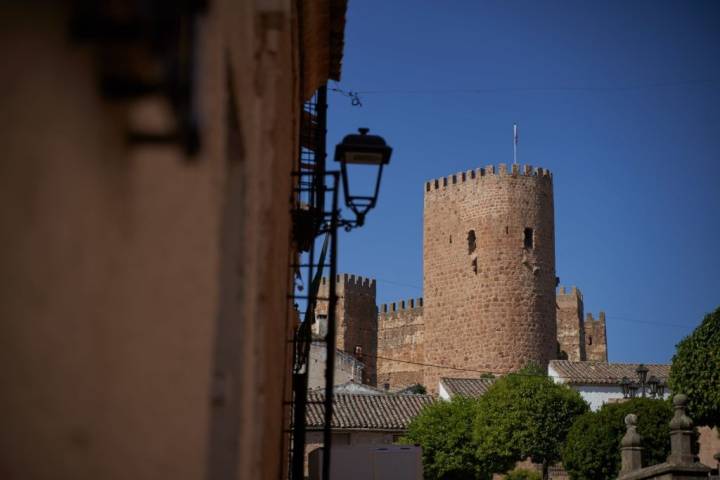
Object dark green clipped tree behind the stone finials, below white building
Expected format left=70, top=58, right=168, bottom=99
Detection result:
left=562, top=398, right=672, bottom=480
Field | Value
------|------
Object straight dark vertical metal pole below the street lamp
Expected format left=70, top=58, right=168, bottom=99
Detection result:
left=322, top=172, right=340, bottom=480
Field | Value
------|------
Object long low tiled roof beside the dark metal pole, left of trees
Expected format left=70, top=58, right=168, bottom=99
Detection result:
left=306, top=392, right=435, bottom=431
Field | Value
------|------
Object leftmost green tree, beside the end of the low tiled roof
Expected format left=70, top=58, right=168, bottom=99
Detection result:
left=401, top=396, right=489, bottom=480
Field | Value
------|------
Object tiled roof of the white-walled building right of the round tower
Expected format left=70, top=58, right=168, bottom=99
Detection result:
left=549, top=360, right=670, bottom=385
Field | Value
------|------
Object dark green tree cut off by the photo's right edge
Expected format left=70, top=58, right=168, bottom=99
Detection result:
left=669, top=307, right=720, bottom=427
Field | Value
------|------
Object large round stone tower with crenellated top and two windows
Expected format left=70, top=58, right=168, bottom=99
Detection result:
left=423, top=164, right=557, bottom=391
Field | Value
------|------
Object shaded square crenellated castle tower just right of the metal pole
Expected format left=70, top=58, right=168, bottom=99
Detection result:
left=316, top=274, right=378, bottom=385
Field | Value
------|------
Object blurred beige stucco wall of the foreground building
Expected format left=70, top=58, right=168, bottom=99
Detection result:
left=0, top=0, right=299, bottom=480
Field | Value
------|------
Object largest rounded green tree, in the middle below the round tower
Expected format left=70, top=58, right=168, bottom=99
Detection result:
left=474, top=366, right=588, bottom=478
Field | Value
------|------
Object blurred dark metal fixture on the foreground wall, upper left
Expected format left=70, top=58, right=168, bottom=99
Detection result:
left=70, top=0, right=208, bottom=159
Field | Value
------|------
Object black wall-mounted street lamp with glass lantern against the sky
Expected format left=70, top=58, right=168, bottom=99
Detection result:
left=335, top=128, right=392, bottom=228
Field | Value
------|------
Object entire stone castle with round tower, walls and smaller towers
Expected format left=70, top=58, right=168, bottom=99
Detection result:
left=317, top=164, right=607, bottom=392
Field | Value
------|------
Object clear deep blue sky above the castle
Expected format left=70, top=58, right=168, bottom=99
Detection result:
left=328, top=0, right=720, bottom=363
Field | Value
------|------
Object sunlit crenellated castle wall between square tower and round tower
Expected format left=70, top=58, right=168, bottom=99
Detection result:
left=377, top=298, right=425, bottom=390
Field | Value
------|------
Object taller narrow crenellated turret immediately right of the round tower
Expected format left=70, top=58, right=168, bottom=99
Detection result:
left=555, top=287, right=586, bottom=361
